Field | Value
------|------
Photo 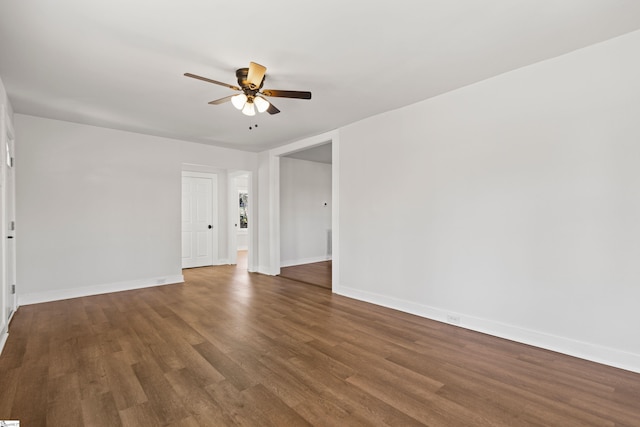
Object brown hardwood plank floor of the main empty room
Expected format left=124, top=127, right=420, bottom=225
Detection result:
left=0, top=266, right=640, bottom=427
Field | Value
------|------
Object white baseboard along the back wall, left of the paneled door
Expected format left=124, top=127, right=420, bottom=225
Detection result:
left=18, top=274, right=184, bottom=305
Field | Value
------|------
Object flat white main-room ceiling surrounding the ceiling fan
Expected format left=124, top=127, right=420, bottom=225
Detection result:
left=0, top=0, right=640, bottom=151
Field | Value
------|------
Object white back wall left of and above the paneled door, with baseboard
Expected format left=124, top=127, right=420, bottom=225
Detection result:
left=15, top=114, right=257, bottom=304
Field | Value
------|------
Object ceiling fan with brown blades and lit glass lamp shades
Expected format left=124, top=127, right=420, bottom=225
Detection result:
left=184, top=62, right=311, bottom=116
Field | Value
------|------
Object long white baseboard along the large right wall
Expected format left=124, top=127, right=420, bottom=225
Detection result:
left=333, top=286, right=640, bottom=373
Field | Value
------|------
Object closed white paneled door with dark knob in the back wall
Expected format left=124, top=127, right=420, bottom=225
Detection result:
left=182, top=172, right=218, bottom=268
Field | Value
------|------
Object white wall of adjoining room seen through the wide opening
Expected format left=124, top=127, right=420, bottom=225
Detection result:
left=280, top=157, right=331, bottom=267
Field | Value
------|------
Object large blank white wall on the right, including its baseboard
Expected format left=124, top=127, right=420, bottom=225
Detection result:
left=334, top=32, right=640, bottom=371
